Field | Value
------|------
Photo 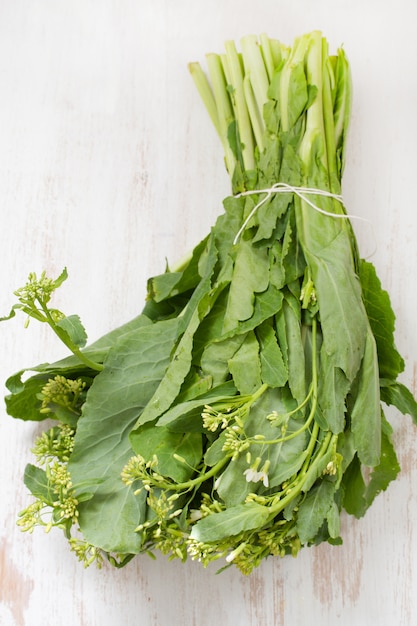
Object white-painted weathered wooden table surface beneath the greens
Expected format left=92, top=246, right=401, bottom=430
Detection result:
left=0, top=0, right=417, bottom=626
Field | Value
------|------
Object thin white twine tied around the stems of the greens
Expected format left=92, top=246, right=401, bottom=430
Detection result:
left=233, top=183, right=370, bottom=245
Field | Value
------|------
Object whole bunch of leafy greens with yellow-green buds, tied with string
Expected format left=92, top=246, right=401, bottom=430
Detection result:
left=6, top=32, right=417, bottom=574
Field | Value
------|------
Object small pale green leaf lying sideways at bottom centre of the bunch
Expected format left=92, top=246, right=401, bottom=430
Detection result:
left=191, top=502, right=269, bottom=543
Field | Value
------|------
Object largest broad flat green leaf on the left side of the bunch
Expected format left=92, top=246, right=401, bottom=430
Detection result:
left=68, top=320, right=178, bottom=553
